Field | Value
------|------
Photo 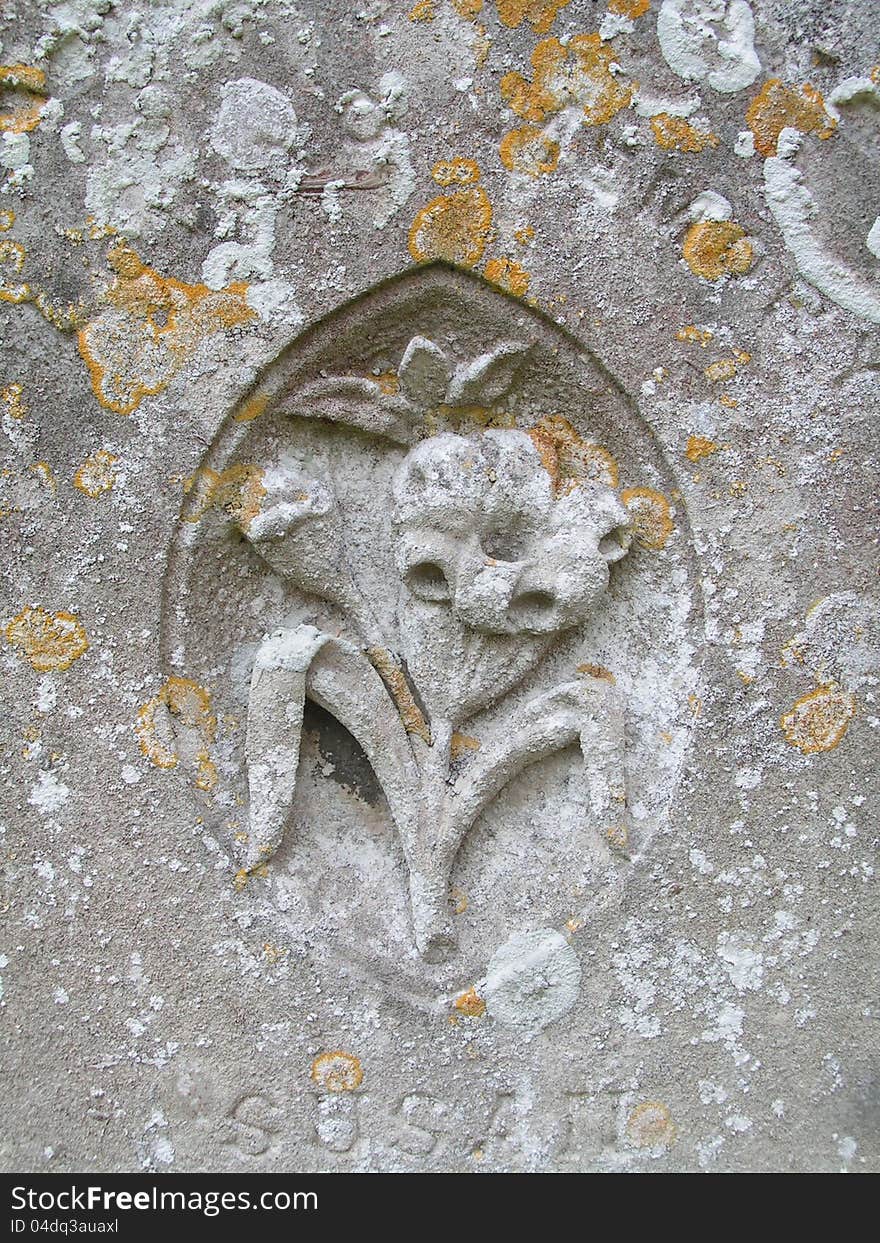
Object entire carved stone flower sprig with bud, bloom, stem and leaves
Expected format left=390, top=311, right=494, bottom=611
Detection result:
left=229, top=337, right=629, bottom=961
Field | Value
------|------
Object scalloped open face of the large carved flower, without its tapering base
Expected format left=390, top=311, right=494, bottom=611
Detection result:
left=394, top=429, right=628, bottom=635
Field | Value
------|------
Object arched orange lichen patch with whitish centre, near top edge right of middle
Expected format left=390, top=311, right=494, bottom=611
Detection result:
left=501, top=35, right=633, bottom=126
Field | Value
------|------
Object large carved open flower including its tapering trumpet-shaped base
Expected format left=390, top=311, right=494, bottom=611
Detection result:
left=394, top=429, right=628, bottom=732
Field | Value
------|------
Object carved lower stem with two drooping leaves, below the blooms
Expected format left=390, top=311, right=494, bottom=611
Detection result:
left=246, top=625, right=626, bottom=962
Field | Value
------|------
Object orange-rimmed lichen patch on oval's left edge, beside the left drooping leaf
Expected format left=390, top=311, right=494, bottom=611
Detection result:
left=134, top=676, right=218, bottom=789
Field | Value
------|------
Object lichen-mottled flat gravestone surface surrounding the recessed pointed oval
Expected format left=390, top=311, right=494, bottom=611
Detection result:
left=0, top=0, right=880, bottom=1171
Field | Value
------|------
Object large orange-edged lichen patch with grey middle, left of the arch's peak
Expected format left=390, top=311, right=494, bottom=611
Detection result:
left=77, top=242, right=256, bottom=414
